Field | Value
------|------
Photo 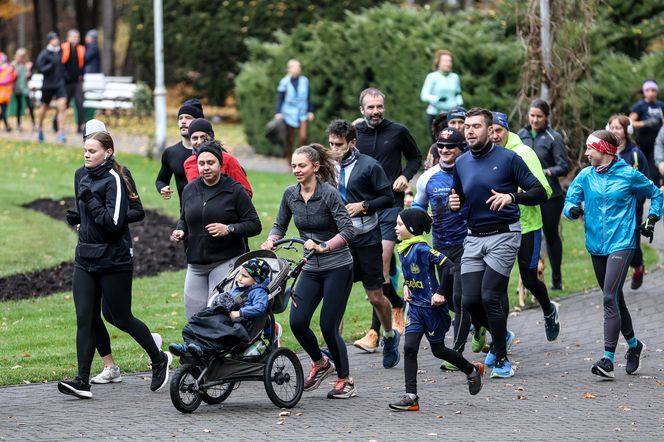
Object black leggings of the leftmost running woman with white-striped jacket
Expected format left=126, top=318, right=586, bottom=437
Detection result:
left=73, top=268, right=162, bottom=382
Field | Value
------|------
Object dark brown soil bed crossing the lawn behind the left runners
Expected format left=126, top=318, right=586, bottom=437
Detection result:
left=0, top=198, right=186, bottom=301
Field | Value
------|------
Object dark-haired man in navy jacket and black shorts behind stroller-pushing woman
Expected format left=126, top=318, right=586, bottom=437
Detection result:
left=327, top=120, right=400, bottom=368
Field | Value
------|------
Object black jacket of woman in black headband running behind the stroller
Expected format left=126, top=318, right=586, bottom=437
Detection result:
left=177, top=175, right=261, bottom=264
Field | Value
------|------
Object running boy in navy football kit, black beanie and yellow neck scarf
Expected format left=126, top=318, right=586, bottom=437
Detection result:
left=389, top=209, right=484, bottom=411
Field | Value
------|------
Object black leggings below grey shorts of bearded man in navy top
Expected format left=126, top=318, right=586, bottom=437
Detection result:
left=461, top=266, right=509, bottom=361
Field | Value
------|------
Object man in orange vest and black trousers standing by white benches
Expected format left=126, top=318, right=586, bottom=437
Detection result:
left=61, top=29, right=85, bottom=134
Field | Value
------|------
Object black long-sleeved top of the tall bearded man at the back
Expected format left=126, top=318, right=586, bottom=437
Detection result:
left=355, top=119, right=422, bottom=207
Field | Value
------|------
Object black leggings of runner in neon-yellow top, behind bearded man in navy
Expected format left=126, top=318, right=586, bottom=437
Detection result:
left=517, top=230, right=551, bottom=316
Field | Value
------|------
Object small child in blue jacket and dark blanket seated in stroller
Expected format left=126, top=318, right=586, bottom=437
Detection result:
left=168, top=258, right=271, bottom=357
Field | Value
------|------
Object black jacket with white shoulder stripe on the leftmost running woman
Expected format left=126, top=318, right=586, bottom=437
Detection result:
left=74, top=161, right=133, bottom=272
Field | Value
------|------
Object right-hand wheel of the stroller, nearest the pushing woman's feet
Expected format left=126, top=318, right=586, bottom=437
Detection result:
left=263, top=347, right=304, bottom=408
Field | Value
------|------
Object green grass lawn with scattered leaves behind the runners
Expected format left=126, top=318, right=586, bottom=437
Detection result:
left=0, top=142, right=657, bottom=385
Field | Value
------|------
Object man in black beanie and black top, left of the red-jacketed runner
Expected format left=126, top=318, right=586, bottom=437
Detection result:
left=155, top=98, right=205, bottom=207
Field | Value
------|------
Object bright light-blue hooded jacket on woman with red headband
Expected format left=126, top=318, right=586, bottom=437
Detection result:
left=563, top=158, right=662, bottom=256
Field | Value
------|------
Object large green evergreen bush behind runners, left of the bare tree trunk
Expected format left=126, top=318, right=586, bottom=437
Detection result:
left=235, top=5, right=523, bottom=154
